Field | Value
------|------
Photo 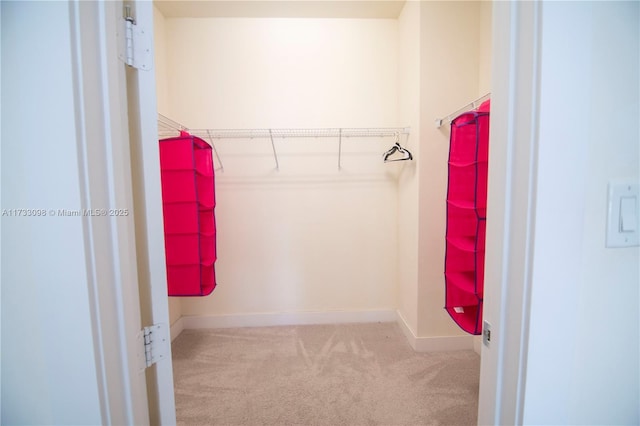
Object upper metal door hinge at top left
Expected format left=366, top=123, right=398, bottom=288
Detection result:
left=117, top=5, right=152, bottom=71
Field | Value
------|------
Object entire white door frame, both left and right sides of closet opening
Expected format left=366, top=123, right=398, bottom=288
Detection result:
left=76, top=0, right=541, bottom=424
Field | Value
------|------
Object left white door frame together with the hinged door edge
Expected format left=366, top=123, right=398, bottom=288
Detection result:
left=69, top=0, right=176, bottom=425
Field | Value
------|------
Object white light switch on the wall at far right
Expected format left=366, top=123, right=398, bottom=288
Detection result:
left=607, top=182, right=640, bottom=247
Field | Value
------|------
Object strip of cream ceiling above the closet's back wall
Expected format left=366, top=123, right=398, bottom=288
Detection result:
left=154, top=0, right=405, bottom=19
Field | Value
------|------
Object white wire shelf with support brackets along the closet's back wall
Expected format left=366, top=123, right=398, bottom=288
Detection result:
left=158, top=114, right=411, bottom=170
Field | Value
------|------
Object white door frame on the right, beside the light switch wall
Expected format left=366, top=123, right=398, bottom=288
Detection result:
left=478, top=0, right=542, bottom=424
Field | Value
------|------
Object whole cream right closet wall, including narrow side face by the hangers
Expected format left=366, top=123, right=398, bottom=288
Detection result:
left=398, top=2, right=491, bottom=350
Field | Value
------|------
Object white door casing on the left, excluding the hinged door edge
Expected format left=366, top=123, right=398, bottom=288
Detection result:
left=69, top=1, right=149, bottom=424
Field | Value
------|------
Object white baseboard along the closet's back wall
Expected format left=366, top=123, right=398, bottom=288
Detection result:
left=180, top=310, right=396, bottom=335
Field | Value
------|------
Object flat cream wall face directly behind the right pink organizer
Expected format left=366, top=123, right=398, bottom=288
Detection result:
left=417, top=2, right=481, bottom=336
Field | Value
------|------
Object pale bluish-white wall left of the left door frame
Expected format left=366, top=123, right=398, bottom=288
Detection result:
left=1, top=2, right=102, bottom=424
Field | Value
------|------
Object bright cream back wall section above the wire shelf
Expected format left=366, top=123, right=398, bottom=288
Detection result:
left=166, top=18, right=397, bottom=128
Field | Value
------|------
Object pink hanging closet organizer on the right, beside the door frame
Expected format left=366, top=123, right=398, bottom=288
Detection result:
left=444, top=101, right=490, bottom=334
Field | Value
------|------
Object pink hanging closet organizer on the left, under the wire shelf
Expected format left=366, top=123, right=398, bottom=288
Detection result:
left=160, top=131, right=216, bottom=296
